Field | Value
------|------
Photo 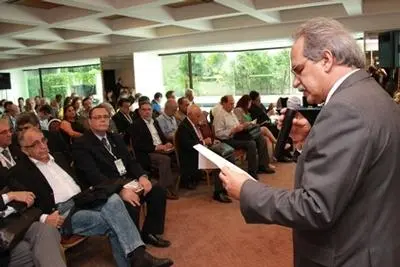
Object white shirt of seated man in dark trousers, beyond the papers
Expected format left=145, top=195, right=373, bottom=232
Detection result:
left=214, top=109, right=240, bottom=140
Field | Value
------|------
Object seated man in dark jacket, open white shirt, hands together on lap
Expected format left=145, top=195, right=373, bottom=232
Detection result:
left=128, top=102, right=178, bottom=199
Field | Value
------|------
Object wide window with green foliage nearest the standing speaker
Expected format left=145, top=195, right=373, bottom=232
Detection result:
left=162, top=48, right=296, bottom=96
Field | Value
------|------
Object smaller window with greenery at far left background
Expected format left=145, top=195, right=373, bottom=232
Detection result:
left=24, top=64, right=101, bottom=99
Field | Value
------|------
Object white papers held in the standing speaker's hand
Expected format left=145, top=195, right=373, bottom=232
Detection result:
left=193, top=144, right=256, bottom=181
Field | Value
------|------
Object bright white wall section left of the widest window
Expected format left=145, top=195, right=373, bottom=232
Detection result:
left=133, top=53, right=165, bottom=99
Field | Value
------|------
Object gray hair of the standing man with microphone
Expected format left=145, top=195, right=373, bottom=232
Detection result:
left=293, top=17, right=365, bottom=68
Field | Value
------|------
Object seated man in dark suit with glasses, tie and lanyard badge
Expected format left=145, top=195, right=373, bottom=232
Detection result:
left=72, top=107, right=170, bottom=247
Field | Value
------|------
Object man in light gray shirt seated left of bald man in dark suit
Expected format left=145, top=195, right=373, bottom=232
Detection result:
left=156, top=99, right=178, bottom=142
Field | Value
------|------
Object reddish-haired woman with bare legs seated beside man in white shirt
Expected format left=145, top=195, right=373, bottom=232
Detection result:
left=233, top=95, right=276, bottom=168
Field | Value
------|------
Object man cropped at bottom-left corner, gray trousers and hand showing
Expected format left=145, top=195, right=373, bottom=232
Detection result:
left=0, top=186, right=67, bottom=267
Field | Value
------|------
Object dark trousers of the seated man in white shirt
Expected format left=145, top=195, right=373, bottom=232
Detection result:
left=223, top=136, right=269, bottom=177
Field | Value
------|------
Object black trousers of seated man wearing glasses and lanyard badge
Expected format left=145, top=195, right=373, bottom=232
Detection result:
left=124, top=185, right=167, bottom=235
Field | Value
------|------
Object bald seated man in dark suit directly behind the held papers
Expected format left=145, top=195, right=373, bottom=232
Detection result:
left=175, top=105, right=234, bottom=203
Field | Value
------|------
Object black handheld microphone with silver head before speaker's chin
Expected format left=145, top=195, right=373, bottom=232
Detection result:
left=274, top=96, right=301, bottom=160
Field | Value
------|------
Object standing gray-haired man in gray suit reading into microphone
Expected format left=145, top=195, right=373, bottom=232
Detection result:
left=220, top=18, right=400, bottom=267
